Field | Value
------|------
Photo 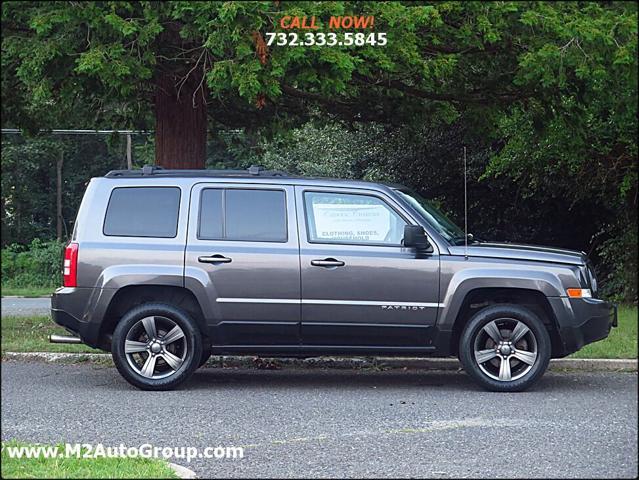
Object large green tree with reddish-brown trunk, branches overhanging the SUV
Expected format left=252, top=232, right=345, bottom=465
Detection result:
left=2, top=1, right=637, bottom=167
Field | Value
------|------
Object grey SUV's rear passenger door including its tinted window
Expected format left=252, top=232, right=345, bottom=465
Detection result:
left=185, top=183, right=301, bottom=349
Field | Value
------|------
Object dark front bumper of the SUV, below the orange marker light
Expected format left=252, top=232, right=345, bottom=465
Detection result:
left=549, top=297, right=617, bottom=356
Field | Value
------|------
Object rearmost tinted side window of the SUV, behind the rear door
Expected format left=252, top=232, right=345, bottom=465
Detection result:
left=103, top=187, right=180, bottom=238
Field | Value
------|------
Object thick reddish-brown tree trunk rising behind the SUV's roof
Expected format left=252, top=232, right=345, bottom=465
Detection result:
left=155, top=71, right=207, bottom=168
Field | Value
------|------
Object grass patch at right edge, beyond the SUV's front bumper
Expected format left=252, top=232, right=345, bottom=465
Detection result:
left=571, top=305, right=637, bottom=358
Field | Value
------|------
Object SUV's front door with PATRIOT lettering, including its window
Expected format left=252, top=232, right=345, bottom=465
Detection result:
left=295, top=187, right=439, bottom=351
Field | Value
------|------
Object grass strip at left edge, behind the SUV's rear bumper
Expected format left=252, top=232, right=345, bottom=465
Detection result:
left=0, top=315, right=101, bottom=353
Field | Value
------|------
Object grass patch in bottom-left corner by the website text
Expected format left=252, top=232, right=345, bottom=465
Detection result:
left=1, top=440, right=178, bottom=478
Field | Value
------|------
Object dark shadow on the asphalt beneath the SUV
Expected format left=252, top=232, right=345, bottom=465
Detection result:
left=56, top=365, right=637, bottom=395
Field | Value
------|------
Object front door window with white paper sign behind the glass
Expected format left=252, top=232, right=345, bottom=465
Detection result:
left=304, top=192, right=406, bottom=246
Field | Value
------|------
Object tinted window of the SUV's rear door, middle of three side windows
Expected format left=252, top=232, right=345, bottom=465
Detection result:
left=198, top=188, right=287, bottom=242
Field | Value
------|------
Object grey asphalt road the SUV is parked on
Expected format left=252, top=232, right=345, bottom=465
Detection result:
left=2, top=361, right=637, bottom=478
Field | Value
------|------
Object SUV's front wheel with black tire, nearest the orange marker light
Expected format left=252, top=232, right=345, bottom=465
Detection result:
left=459, top=304, right=552, bottom=392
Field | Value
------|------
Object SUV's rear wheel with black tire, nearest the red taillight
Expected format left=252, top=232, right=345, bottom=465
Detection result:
left=111, top=303, right=202, bottom=390
